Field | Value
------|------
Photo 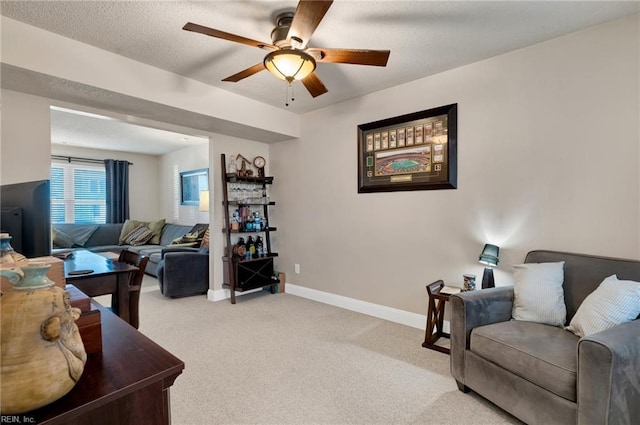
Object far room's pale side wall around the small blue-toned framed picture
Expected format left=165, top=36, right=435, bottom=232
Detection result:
left=158, top=143, right=211, bottom=224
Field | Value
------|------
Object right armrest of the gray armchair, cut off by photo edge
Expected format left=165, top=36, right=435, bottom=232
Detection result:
left=577, top=320, right=640, bottom=424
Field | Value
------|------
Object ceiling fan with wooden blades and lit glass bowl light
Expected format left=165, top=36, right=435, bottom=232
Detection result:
left=182, top=0, right=390, bottom=105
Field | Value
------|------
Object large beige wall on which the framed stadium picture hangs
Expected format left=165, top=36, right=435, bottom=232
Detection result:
left=271, top=17, right=640, bottom=314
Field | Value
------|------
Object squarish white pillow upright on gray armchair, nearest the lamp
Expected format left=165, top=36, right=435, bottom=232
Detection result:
left=511, top=261, right=567, bottom=326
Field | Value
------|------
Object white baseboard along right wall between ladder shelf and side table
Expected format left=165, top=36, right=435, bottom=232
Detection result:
left=285, top=283, right=438, bottom=330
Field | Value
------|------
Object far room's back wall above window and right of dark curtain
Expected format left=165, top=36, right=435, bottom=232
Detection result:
left=52, top=145, right=163, bottom=221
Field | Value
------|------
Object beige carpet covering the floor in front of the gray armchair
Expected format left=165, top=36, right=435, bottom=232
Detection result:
left=116, top=276, right=520, bottom=425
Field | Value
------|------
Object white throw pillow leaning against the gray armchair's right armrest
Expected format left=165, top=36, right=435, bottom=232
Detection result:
left=567, top=275, right=640, bottom=337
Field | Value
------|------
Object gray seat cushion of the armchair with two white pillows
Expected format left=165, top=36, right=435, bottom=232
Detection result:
left=470, top=320, right=579, bottom=402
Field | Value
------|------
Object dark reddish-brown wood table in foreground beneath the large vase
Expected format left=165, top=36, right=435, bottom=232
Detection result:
left=25, top=301, right=184, bottom=425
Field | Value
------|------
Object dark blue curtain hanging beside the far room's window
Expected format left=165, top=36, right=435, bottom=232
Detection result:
left=104, top=159, right=129, bottom=223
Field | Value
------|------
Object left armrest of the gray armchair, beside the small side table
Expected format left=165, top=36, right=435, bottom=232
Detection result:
left=449, top=286, right=513, bottom=385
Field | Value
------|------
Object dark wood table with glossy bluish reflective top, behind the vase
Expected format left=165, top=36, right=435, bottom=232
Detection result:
left=64, top=250, right=138, bottom=323
